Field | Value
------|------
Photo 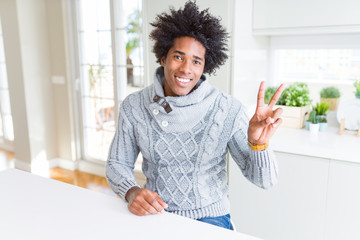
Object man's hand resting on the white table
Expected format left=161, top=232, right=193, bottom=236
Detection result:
left=125, top=187, right=168, bottom=216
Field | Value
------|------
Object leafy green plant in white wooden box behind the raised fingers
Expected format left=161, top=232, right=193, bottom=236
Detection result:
left=264, top=83, right=311, bottom=128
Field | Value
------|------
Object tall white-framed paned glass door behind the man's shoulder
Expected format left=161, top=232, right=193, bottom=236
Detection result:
left=75, top=0, right=146, bottom=160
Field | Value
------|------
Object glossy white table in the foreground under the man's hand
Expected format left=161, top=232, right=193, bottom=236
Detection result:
left=0, top=169, right=258, bottom=240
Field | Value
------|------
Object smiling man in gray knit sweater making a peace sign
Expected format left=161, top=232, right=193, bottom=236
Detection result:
left=106, top=2, right=283, bottom=229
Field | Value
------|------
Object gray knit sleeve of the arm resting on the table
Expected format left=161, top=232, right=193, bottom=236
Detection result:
left=106, top=101, right=139, bottom=200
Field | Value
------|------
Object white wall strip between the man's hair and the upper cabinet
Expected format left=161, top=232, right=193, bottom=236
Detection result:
left=231, top=0, right=269, bottom=109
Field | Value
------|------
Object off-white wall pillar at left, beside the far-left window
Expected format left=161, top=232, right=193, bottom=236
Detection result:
left=0, top=0, right=57, bottom=171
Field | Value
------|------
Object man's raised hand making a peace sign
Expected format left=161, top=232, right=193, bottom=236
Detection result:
left=248, top=82, right=285, bottom=144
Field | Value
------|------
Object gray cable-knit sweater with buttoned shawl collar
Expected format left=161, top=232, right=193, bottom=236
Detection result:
left=106, top=67, right=278, bottom=219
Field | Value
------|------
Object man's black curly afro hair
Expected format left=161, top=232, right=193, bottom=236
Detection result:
left=150, top=1, right=229, bottom=74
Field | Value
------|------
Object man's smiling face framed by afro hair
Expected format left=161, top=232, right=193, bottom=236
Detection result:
left=161, top=37, right=206, bottom=96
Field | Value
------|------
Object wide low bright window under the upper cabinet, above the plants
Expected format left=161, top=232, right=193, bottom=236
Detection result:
left=275, top=49, right=360, bottom=84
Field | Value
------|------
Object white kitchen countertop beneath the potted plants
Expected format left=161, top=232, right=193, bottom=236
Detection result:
left=270, top=127, right=360, bottom=163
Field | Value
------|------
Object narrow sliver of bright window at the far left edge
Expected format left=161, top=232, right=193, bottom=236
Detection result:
left=0, top=18, right=14, bottom=149
